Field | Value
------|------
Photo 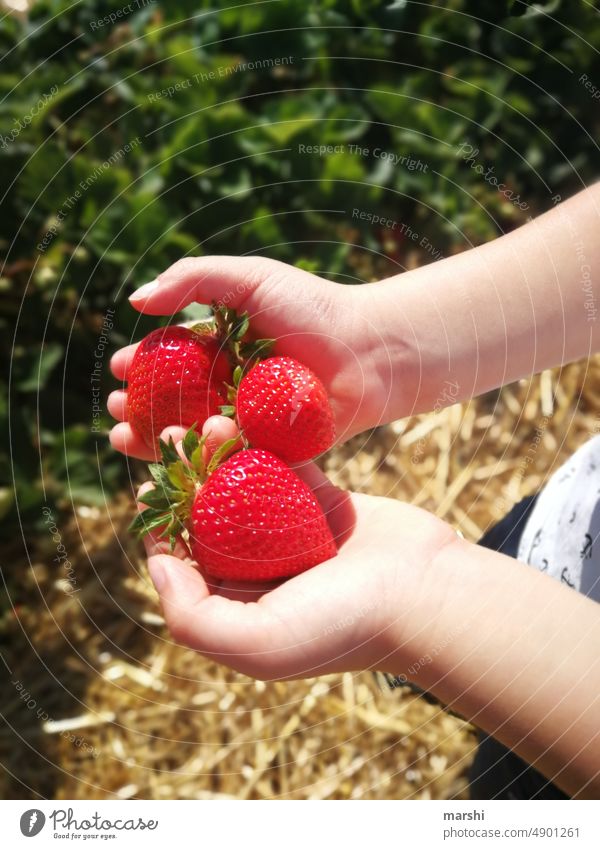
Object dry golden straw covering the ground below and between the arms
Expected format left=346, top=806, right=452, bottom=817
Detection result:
left=0, top=359, right=600, bottom=799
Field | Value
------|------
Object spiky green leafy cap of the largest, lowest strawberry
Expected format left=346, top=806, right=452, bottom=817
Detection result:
left=129, top=424, right=239, bottom=551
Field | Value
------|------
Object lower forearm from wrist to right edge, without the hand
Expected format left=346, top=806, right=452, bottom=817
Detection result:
left=394, top=539, right=600, bottom=798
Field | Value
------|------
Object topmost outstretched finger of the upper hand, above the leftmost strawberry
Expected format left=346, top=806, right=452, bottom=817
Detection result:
left=129, top=256, right=290, bottom=315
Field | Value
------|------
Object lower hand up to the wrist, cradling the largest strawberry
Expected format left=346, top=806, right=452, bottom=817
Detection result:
left=141, top=444, right=458, bottom=680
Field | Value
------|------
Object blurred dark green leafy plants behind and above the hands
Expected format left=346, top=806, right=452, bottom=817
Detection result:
left=0, top=0, right=600, bottom=518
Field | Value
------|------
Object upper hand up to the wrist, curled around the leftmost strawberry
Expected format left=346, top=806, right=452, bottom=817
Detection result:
left=108, top=257, right=392, bottom=460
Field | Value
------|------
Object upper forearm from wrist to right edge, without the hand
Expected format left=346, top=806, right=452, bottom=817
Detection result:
left=364, top=184, right=600, bottom=418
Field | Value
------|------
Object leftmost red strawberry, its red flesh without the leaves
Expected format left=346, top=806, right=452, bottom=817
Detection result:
left=127, top=327, right=232, bottom=447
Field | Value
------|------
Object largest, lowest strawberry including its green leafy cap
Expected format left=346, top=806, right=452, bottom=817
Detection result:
left=132, top=429, right=336, bottom=581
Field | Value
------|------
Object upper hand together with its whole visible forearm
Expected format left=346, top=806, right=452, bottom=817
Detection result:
left=109, top=183, right=600, bottom=459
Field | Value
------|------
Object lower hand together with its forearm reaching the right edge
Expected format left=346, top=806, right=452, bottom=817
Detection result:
left=134, top=434, right=600, bottom=798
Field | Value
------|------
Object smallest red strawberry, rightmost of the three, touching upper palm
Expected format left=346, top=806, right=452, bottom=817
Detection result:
left=237, top=357, right=335, bottom=463
